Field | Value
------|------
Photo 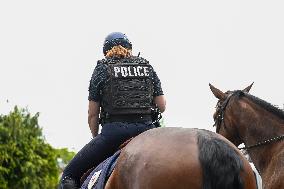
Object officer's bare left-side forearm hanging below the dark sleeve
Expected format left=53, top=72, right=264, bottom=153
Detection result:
left=88, top=100, right=100, bottom=137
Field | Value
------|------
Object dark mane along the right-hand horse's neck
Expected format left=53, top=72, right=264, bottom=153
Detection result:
left=243, top=93, right=284, bottom=119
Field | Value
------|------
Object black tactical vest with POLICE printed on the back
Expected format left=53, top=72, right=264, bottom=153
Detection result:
left=102, top=58, right=153, bottom=115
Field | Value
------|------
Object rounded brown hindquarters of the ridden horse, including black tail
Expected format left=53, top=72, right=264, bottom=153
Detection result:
left=101, top=128, right=256, bottom=189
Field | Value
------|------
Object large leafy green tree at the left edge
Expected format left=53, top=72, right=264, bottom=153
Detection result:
left=0, top=107, right=59, bottom=189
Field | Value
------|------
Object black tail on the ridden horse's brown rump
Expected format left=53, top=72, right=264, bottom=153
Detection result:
left=197, top=130, right=244, bottom=189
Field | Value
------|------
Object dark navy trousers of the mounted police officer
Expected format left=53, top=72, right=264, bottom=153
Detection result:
left=62, top=122, right=154, bottom=183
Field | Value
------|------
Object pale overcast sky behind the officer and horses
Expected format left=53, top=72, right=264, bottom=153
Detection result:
left=0, top=0, right=284, bottom=150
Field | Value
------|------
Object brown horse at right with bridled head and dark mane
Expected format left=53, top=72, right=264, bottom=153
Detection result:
left=210, top=84, right=284, bottom=189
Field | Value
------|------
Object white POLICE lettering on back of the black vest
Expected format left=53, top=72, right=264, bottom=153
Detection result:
left=113, top=66, right=149, bottom=77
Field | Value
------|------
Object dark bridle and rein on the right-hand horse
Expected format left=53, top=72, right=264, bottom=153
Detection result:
left=213, top=91, right=284, bottom=150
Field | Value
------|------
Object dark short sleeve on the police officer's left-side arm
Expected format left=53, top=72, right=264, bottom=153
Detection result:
left=88, top=61, right=107, bottom=102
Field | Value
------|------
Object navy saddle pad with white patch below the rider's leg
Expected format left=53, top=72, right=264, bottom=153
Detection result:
left=81, top=150, right=120, bottom=189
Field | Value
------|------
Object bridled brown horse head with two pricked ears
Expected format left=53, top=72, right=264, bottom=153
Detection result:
left=209, top=83, right=253, bottom=146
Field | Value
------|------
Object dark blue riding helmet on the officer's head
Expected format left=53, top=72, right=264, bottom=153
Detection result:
left=103, top=32, right=132, bottom=55
